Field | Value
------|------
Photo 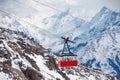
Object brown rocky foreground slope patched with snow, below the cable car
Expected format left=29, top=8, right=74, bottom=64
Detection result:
left=0, top=27, right=117, bottom=80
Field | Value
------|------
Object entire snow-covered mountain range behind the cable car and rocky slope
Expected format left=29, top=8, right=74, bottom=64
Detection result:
left=0, top=7, right=120, bottom=79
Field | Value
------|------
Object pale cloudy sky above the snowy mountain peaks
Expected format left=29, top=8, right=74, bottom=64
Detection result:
left=0, top=0, right=120, bottom=20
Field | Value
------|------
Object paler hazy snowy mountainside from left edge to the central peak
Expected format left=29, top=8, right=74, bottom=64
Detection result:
left=0, top=9, right=89, bottom=51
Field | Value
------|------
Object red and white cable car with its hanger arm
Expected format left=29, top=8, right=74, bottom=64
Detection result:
left=58, top=37, right=78, bottom=67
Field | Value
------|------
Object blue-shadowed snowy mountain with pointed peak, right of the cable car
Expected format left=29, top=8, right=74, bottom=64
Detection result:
left=73, top=7, right=120, bottom=76
